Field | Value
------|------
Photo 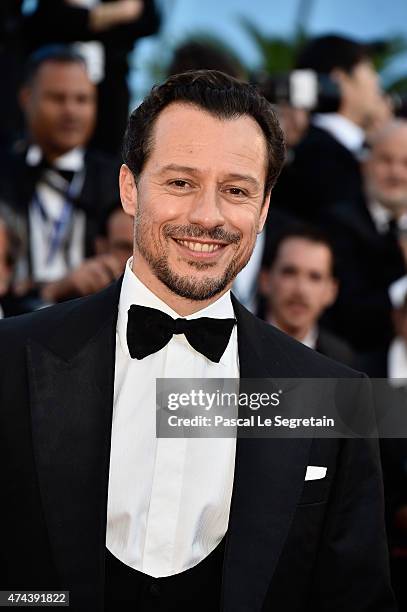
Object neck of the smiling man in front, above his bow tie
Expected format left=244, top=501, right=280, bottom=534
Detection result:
left=132, top=254, right=230, bottom=317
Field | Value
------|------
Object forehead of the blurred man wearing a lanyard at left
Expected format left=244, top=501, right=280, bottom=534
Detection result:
left=34, top=61, right=94, bottom=92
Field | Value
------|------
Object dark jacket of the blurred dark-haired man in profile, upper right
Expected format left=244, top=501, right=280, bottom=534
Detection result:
left=272, top=126, right=363, bottom=222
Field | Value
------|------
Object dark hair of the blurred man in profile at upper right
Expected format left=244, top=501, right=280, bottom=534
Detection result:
left=296, top=34, right=373, bottom=74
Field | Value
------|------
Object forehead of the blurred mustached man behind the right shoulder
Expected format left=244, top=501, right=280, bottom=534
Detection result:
left=277, top=236, right=332, bottom=270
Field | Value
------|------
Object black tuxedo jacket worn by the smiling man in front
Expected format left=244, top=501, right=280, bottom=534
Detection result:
left=0, top=281, right=395, bottom=612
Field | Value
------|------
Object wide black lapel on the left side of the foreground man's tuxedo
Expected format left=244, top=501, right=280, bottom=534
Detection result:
left=27, top=283, right=120, bottom=610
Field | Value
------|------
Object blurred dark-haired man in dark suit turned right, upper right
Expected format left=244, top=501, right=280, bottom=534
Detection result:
left=273, top=35, right=380, bottom=221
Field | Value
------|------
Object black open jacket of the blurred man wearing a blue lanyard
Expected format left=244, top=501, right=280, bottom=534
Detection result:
left=0, top=149, right=120, bottom=274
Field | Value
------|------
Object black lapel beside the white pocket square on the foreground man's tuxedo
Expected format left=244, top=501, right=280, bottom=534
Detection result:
left=222, top=298, right=311, bottom=612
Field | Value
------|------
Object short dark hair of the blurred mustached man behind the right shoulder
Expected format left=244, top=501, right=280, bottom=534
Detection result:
left=262, top=222, right=337, bottom=278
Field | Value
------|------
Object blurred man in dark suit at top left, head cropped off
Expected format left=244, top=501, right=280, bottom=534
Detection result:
left=23, top=0, right=160, bottom=156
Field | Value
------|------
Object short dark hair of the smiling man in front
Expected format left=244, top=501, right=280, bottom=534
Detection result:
left=123, top=70, right=285, bottom=194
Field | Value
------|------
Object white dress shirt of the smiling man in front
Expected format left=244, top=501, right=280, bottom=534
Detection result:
left=106, top=258, right=239, bottom=578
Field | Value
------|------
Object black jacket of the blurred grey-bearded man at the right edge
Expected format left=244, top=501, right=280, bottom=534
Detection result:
left=321, top=202, right=406, bottom=352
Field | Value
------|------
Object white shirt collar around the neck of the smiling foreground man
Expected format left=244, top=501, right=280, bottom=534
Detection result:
left=117, top=257, right=235, bottom=356
